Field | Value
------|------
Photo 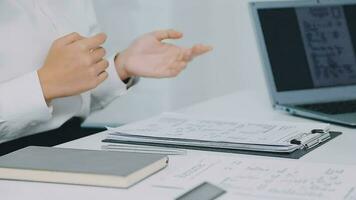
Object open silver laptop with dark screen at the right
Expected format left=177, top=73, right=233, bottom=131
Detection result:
left=250, top=0, right=356, bottom=127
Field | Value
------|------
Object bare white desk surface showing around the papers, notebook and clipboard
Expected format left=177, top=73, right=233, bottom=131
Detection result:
left=0, top=92, right=356, bottom=200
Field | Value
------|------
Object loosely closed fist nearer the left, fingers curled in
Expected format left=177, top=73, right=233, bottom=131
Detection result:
left=37, top=33, right=109, bottom=102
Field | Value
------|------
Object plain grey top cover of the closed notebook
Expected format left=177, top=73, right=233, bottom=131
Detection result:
left=0, top=146, right=167, bottom=185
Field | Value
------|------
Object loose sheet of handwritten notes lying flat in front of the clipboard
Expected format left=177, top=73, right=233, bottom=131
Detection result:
left=151, top=156, right=356, bottom=200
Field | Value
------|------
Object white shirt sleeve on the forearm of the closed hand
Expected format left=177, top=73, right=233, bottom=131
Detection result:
left=0, top=71, right=52, bottom=143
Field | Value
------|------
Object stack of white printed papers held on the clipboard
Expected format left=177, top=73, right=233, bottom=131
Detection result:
left=109, top=113, right=329, bottom=146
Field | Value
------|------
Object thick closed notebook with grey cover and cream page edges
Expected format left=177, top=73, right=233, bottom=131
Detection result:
left=0, top=146, right=168, bottom=188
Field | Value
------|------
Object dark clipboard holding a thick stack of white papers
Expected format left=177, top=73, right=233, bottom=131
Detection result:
left=104, top=113, right=342, bottom=158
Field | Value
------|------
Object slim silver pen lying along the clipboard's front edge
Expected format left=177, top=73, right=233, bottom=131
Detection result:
left=101, top=144, right=187, bottom=155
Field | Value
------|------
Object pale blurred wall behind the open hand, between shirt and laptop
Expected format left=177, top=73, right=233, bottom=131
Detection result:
left=84, top=0, right=280, bottom=125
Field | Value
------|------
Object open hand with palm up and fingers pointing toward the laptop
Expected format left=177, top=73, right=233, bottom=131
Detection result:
left=115, top=30, right=212, bottom=80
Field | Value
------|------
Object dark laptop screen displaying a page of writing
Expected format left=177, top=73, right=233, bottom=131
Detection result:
left=258, top=5, right=356, bottom=92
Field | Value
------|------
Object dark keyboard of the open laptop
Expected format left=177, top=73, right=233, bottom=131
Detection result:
left=296, top=100, right=356, bottom=115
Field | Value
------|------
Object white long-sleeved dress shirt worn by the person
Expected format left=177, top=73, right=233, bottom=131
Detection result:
left=0, top=0, right=127, bottom=143
